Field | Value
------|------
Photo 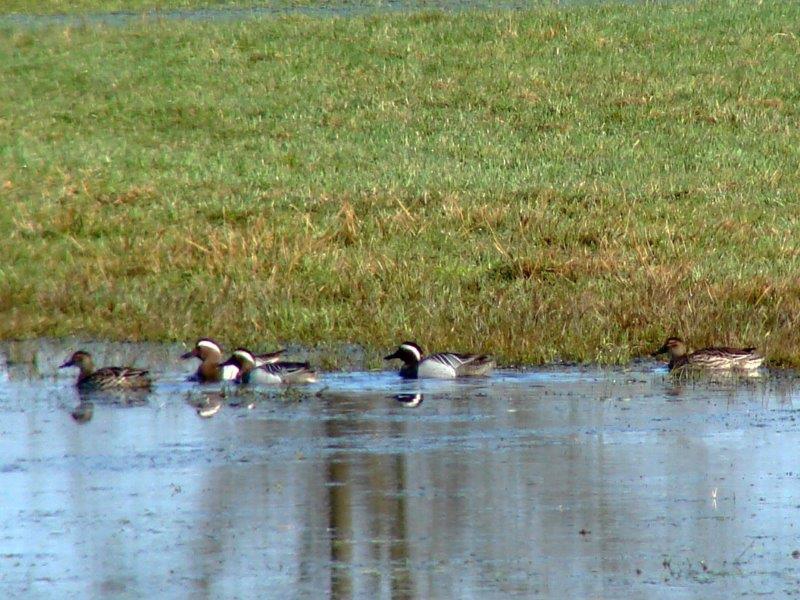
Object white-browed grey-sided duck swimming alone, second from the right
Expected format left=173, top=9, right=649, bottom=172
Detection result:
left=383, top=342, right=495, bottom=379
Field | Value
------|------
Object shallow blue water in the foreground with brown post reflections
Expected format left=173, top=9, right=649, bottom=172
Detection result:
left=0, top=340, right=800, bottom=598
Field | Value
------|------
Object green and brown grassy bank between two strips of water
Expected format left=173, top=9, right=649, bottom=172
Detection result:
left=0, top=2, right=800, bottom=364
